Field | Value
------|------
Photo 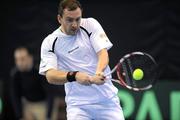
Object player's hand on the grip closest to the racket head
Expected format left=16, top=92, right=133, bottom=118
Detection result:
left=90, top=74, right=105, bottom=85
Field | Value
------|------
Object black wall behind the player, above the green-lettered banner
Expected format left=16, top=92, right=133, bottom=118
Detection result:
left=0, top=0, right=180, bottom=120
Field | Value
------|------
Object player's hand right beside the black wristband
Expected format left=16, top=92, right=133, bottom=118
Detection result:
left=76, top=72, right=91, bottom=85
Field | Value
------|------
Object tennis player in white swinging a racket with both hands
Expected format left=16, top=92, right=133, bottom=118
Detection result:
left=39, top=0, right=124, bottom=120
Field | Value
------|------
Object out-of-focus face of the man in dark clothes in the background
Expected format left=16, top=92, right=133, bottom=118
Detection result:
left=14, top=50, right=33, bottom=72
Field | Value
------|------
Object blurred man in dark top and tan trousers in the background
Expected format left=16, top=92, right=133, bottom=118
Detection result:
left=10, top=47, right=53, bottom=120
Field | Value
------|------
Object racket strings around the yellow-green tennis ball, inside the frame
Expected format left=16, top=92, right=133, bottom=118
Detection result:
left=121, top=55, right=156, bottom=88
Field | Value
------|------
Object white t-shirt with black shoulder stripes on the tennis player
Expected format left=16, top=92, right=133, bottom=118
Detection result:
left=39, top=18, right=118, bottom=105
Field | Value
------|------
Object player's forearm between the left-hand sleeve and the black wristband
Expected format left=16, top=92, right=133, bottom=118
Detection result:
left=46, top=69, right=68, bottom=84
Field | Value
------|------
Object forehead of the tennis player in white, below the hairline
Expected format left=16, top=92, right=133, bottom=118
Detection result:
left=63, top=8, right=82, bottom=18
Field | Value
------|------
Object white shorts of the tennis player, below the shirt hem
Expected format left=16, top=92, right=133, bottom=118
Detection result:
left=66, top=96, right=124, bottom=120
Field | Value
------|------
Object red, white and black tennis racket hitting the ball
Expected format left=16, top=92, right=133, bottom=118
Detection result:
left=105, top=52, right=157, bottom=91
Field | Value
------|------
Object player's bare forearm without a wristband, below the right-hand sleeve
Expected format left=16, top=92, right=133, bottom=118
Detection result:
left=96, top=49, right=109, bottom=74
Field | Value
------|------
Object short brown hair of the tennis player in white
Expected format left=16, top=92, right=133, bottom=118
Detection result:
left=58, top=0, right=82, bottom=16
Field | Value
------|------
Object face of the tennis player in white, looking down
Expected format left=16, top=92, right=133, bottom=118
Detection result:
left=58, top=8, right=82, bottom=35
